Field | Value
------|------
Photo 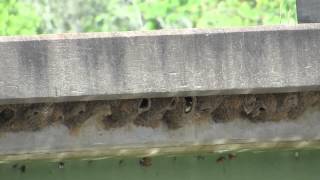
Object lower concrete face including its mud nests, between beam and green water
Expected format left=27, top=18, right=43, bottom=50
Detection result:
left=0, top=92, right=320, bottom=162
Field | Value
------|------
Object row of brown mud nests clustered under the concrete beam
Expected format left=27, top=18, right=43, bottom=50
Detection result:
left=0, top=92, right=320, bottom=132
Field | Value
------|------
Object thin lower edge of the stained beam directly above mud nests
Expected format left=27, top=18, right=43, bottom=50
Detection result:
left=0, top=85, right=320, bottom=105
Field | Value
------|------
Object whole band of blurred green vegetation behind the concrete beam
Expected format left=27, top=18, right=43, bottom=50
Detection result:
left=0, top=0, right=296, bottom=35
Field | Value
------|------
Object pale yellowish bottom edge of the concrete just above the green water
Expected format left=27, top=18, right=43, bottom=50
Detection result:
left=0, top=140, right=320, bottom=163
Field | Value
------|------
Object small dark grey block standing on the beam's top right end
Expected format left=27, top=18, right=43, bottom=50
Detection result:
left=297, top=0, right=320, bottom=23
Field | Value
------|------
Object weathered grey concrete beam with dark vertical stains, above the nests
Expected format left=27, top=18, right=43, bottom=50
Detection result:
left=0, top=24, right=320, bottom=104
